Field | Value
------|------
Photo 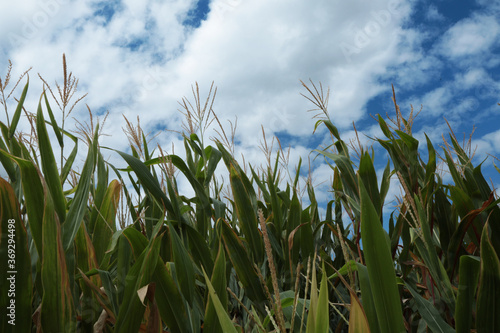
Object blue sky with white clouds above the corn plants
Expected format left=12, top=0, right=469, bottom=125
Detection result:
left=0, top=0, right=500, bottom=219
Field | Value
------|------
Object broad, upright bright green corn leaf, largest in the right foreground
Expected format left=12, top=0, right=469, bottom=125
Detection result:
left=358, top=177, right=405, bottom=332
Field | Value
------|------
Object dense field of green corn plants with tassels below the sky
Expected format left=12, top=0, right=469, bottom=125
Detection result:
left=0, top=60, right=500, bottom=333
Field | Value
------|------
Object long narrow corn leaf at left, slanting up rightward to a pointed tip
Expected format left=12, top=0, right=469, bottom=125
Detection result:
left=62, top=129, right=99, bottom=251
